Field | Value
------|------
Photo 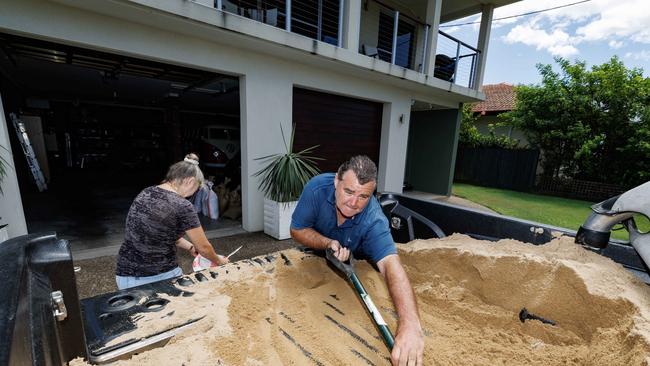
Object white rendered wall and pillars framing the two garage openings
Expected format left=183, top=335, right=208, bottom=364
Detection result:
left=0, top=0, right=466, bottom=231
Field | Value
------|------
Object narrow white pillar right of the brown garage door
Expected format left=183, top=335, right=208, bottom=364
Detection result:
left=377, top=96, right=411, bottom=193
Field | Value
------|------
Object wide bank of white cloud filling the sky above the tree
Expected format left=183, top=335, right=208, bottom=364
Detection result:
left=494, top=0, right=650, bottom=57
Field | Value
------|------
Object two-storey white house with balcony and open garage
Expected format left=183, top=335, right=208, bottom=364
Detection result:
left=0, top=0, right=516, bottom=243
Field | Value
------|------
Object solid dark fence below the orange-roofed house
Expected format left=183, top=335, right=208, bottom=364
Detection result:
left=454, top=146, right=539, bottom=191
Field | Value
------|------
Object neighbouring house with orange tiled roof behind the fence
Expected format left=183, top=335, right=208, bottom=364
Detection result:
left=472, top=83, right=528, bottom=146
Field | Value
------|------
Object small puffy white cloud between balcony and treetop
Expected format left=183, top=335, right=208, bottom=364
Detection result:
left=504, top=23, right=580, bottom=57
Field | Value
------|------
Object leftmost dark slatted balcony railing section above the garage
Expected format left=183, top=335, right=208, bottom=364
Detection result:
left=214, top=0, right=344, bottom=47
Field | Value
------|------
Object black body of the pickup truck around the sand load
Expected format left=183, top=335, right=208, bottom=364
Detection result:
left=0, top=193, right=650, bottom=366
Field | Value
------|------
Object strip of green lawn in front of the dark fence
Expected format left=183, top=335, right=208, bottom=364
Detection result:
left=452, top=183, right=650, bottom=240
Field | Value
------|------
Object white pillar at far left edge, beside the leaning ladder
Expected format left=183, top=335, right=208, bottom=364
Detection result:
left=0, top=96, right=27, bottom=238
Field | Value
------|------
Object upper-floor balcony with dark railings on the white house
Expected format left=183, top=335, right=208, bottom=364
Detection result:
left=214, top=0, right=479, bottom=89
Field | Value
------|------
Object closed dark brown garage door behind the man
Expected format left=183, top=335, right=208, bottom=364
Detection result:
left=293, top=88, right=382, bottom=172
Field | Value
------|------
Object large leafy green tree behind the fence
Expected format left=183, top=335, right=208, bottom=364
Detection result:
left=506, top=56, right=650, bottom=185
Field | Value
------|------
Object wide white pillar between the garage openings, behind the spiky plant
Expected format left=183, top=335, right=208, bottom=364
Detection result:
left=239, top=69, right=293, bottom=231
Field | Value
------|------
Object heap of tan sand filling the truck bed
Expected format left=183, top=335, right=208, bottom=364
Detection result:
left=71, top=235, right=650, bottom=365
